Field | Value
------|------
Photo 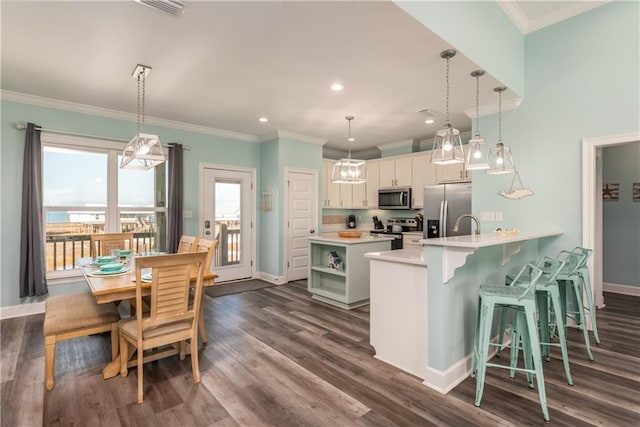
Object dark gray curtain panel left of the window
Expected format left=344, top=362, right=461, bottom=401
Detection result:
left=20, top=123, right=49, bottom=298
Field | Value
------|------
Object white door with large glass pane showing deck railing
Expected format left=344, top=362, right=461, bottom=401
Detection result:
left=200, top=167, right=255, bottom=281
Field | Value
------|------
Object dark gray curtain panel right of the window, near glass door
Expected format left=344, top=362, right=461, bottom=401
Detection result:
left=167, top=144, right=184, bottom=253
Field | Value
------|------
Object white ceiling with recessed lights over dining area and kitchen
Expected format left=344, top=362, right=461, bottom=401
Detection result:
left=1, top=0, right=605, bottom=151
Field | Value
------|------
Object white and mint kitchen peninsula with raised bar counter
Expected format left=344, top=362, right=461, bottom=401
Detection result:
left=365, top=231, right=562, bottom=394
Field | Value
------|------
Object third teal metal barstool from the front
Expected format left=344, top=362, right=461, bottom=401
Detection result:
left=557, top=246, right=600, bottom=360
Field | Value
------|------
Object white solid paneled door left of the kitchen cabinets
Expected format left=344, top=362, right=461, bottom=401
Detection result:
left=286, top=171, right=318, bottom=281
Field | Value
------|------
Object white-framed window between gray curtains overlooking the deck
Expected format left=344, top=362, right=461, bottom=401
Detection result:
left=42, top=133, right=167, bottom=279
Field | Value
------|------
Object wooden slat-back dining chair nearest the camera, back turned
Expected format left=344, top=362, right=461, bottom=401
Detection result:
left=119, top=252, right=207, bottom=403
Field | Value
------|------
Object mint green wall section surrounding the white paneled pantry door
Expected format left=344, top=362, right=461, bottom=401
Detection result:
left=258, top=138, right=322, bottom=276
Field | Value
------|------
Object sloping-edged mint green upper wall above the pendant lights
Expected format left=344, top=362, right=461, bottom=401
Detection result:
left=394, top=0, right=526, bottom=96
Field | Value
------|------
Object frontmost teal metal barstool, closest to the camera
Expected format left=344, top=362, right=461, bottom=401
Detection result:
left=471, top=264, right=549, bottom=421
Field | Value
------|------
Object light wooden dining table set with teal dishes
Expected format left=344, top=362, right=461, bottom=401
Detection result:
left=76, top=256, right=218, bottom=379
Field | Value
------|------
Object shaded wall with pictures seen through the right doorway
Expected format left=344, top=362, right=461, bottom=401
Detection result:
left=602, top=141, right=640, bottom=287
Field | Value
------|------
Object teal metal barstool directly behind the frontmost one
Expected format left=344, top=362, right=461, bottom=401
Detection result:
left=498, top=256, right=573, bottom=385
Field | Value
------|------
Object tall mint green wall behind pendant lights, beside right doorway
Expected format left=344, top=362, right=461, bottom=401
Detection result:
left=473, top=2, right=640, bottom=254
